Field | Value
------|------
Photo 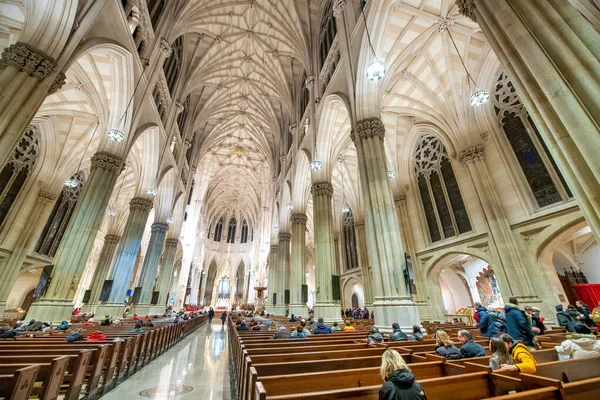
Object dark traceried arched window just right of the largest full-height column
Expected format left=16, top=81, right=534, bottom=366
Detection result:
left=415, top=134, right=471, bottom=242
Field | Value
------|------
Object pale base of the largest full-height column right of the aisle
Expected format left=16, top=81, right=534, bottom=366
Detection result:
left=373, top=297, right=421, bottom=332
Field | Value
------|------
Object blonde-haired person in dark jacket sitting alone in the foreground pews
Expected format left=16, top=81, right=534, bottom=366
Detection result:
left=379, top=349, right=427, bottom=400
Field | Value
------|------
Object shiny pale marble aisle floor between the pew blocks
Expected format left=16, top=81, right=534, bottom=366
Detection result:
left=102, top=318, right=235, bottom=400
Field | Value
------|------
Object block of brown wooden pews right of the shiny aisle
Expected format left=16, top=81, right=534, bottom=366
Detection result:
left=228, top=320, right=600, bottom=400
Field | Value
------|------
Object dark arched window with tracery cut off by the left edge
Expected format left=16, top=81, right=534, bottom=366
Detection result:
left=0, top=126, right=40, bottom=230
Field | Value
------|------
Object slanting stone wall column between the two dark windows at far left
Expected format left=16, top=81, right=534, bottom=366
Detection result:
left=0, top=190, right=56, bottom=312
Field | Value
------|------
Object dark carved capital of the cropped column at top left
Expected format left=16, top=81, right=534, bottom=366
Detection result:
left=0, top=42, right=56, bottom=81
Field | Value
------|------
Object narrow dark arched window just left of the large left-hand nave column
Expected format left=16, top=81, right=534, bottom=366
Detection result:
left=34, top=171, right=84, bottom=257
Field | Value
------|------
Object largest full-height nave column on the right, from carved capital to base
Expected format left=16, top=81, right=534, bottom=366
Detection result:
left=351, top=118, right=420, bottom=329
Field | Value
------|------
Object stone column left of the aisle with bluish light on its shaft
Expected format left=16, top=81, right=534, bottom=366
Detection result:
left=108, top=197, right=152, bottom=305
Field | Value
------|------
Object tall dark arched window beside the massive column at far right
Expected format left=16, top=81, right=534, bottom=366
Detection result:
left=494, top=72, right=573, bottom=208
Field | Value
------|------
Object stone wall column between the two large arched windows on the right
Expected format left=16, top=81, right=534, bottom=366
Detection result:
left=458, top=145, right=559, bottom=316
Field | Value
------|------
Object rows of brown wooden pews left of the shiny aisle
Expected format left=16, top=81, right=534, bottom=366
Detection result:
left=0, top=316, right=208, bottom=400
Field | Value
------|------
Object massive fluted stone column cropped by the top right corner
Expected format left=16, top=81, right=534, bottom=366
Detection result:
left=458, top=0, right=600, bottom=242
